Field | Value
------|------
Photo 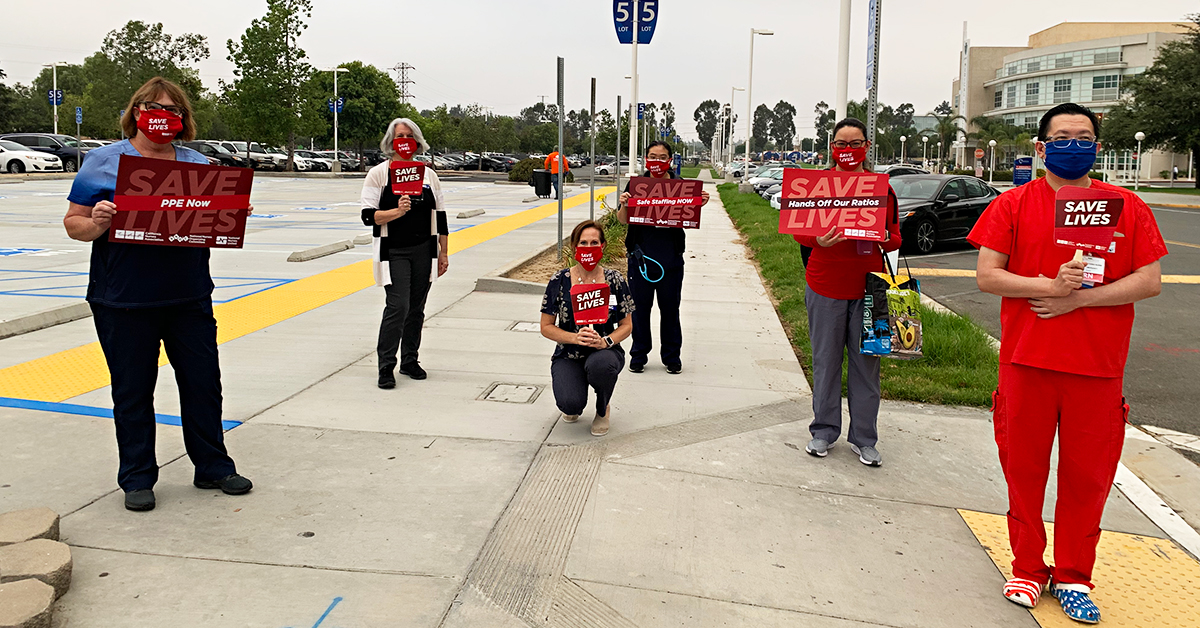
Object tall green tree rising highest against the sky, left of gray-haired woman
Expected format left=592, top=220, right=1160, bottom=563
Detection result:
left=222, top=0, right=325, bottom=171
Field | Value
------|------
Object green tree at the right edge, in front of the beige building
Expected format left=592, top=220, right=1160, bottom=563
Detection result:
left=1100, top=13, right=1200, bottom=189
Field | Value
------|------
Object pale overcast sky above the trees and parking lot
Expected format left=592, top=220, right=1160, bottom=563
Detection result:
left=0, top=0, right=1200, bottom=138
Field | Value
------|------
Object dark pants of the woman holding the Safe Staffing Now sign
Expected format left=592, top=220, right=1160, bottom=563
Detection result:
left=629, top=262, right=683, bottom=366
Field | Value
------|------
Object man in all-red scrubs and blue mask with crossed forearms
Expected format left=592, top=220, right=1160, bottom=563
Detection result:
left=968, top=103, right=1166, bottom=623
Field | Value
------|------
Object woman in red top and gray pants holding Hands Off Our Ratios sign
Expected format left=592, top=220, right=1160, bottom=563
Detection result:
left=794, top=118, right=900, bottom=467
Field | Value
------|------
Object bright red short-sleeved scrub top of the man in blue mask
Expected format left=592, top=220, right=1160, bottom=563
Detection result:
left=967, top=178, right=1166, bottom=377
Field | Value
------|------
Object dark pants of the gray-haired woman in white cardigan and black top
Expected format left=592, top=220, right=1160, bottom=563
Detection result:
left=376, top=244, right=433, bottom=373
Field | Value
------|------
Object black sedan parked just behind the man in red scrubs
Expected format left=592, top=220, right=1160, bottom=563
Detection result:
left=889, top=174, right=1000, bottom=253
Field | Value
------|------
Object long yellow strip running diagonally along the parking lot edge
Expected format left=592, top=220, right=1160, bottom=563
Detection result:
left=0, top=186, right=616, bottom=402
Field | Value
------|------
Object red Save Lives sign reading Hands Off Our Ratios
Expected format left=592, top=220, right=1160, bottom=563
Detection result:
left=779, top=168, right=888, bottom=243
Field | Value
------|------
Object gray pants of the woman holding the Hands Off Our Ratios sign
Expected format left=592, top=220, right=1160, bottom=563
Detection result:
left=804, top=288, right=880, bottom=447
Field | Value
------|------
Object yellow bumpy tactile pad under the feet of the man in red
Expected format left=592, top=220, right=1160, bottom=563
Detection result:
left=959, top=510, right=1200, bottom=628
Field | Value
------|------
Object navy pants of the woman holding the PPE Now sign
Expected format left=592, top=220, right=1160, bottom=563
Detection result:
left=91, top=298, right=235, bottom=491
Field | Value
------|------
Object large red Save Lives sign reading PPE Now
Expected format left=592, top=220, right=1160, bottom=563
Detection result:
left=108, top=155, right=254, bottom=249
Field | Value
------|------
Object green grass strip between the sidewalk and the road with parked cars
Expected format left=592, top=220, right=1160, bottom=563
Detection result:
left=718, top=184, right=998, bottom=407
